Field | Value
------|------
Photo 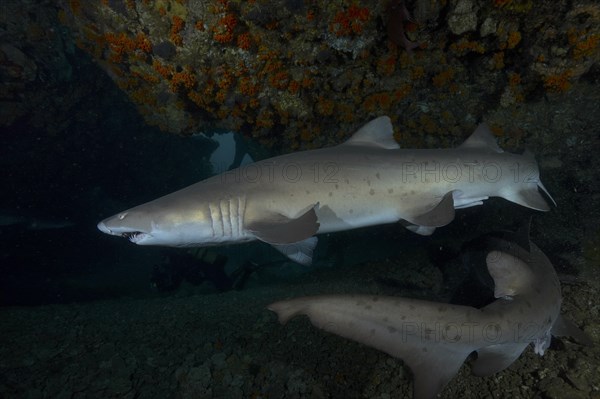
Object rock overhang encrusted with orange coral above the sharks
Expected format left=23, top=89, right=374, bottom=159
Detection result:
left=59, top=0, right=600, bottom=148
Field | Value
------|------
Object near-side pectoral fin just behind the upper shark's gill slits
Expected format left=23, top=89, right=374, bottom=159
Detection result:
left=246, top=204, right=319, bottom=245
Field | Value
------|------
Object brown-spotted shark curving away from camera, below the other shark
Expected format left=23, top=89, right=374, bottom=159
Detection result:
left=268, top=228, right=592, bottom=399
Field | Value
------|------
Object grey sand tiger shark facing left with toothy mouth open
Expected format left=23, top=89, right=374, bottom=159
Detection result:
left=98, top=116, right=553, bottom=265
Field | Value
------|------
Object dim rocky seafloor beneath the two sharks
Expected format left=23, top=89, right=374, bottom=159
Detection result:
left=0, top=250, right=600, bottom=399
